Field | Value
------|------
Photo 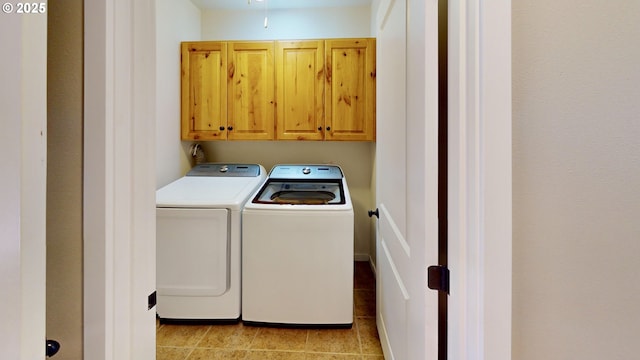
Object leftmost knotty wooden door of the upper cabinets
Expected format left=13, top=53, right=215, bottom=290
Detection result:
left=181, top=42, right=227, bottom=140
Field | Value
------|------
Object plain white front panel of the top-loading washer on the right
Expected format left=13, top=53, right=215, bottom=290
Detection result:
left=242, top=209, right=354, bottom=324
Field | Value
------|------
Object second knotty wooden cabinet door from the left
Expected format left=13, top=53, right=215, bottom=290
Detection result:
left=227, top=41, right=275, bottom=140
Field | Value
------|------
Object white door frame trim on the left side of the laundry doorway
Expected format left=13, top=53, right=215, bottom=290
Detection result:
left=83, top=0, right=156, bottom=360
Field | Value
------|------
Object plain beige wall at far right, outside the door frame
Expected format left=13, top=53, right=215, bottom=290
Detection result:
left=512, top=0, right=640, bottom=360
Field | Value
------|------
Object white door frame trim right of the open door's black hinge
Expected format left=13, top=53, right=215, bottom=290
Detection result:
left=448, top=0, right=512, bottom=360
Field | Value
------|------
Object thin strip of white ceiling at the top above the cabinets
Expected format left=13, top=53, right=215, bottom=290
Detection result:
left=191, top=0, right=372, bottom=10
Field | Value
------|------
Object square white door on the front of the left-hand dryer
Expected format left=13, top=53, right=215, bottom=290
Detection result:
left=156, top=208, right=230, bottom=296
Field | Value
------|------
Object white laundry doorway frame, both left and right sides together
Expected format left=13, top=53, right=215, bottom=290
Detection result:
left=84, top=0, right=511, bottom=360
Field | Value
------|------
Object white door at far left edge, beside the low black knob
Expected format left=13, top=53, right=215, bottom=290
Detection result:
left=0, top=9, right=47, bottom=359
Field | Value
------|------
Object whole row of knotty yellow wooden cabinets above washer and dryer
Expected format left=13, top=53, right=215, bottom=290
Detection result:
left=181, top=38, right=376, bottom=141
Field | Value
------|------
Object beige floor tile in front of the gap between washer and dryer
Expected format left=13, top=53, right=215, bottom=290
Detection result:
left=197, top=323, right=258, bottom=349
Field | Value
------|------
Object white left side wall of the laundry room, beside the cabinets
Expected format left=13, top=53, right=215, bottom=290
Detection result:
left=155, top=0, right=201, bottom=187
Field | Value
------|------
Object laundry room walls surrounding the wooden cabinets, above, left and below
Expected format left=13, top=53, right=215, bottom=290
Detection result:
left=156, top=0, right=375, bottom=261
